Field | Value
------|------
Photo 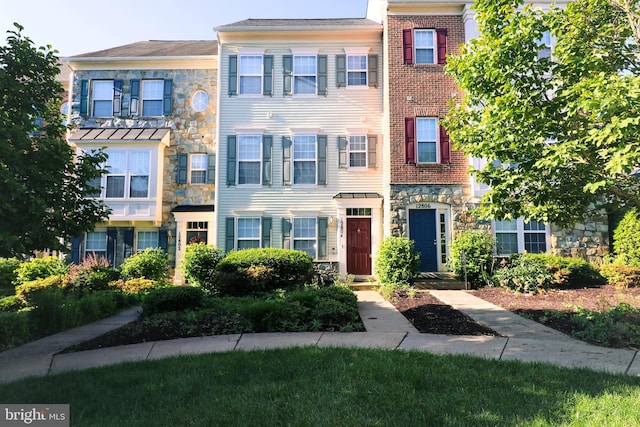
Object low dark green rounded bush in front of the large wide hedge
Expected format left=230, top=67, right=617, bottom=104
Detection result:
left=142, top=286, right=205, bottom=316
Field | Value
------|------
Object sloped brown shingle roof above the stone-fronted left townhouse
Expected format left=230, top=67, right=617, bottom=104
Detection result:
left=69, top=40, right=218, bottom=59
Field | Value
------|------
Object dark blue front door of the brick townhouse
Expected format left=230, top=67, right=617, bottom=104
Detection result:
left=409, top=209, right=438, bottom=272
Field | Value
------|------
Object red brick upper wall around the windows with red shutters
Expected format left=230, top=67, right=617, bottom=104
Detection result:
left=388, top=16, right=469, bottom=184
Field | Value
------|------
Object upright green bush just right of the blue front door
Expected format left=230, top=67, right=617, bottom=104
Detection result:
left=451, top=230, right=495, bottom=287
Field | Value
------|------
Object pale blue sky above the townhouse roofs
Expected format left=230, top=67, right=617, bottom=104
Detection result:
left=0, top=0, right=367, bottom=56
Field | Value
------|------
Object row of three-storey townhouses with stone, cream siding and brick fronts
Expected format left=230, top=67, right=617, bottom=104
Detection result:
left=66, top=0, right=608, bottom=282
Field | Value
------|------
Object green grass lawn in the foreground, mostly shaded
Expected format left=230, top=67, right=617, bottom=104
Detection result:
left=0, top=347, right=640, bottom=427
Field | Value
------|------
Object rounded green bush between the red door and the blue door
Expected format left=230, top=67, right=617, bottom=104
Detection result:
left=374, top=237, right=420, bottom=288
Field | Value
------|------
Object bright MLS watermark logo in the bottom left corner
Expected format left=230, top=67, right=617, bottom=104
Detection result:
left=0, top=404, right=69, bottom=427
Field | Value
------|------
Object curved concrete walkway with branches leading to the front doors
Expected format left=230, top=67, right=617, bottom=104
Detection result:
left=0, top=290, right=640, bottom=383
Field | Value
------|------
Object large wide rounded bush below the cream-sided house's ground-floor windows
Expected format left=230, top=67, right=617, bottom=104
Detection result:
left=211, top=248, right=313, bottom=296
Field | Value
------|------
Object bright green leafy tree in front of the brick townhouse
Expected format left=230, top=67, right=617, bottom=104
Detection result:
left=445, top=0, right=640, bottom=225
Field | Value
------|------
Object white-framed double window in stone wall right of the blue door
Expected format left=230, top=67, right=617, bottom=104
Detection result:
left=494, top=218, right=547, bottom=255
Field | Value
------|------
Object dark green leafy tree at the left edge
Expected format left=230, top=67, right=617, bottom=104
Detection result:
left=0, top=24, right=108, bottom=257
